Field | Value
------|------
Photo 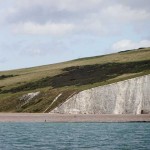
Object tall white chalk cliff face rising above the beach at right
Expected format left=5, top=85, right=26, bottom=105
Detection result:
left=52, top=75, right=150, bottom=114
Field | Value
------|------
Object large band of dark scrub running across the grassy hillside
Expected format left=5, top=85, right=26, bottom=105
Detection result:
left=1, top=60, right=150, bottom=93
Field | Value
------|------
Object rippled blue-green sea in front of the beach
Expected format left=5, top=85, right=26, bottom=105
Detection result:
left=0, top=122, right=150, bottom=150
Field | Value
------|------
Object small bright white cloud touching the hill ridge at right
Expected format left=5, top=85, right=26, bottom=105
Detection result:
left=112, top=40, right=150, bottom=52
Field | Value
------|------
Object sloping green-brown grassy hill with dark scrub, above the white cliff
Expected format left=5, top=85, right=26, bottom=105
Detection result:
left=0, top=48, right=150, bottom=112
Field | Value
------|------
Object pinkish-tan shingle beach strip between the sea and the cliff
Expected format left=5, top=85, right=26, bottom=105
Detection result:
left=0, top=113, right=150, bottom=123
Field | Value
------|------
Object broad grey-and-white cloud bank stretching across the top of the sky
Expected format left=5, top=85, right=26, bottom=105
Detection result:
left=0, top=0, right=150, bottom=36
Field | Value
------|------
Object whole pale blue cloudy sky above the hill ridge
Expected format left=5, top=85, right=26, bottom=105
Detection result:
left=0, top=0, right=150, bottom=71
